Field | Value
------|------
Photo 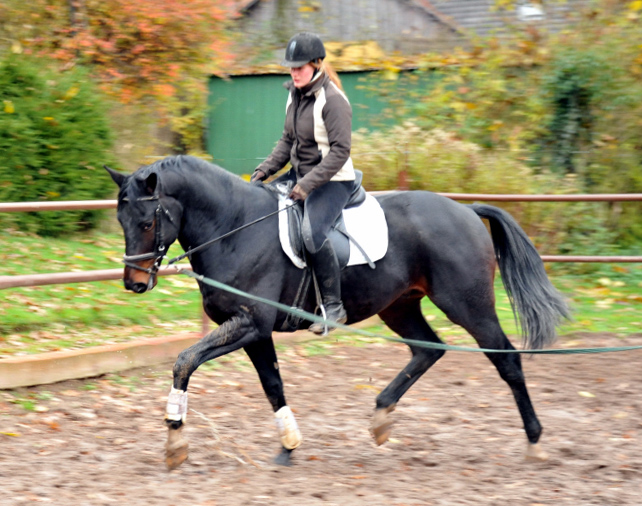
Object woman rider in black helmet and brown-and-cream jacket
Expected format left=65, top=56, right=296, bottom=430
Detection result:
left=251, top=32, right=355, bottom=334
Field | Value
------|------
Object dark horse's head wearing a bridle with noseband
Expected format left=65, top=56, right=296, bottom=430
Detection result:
left=105, top=166, right=183, bottom=293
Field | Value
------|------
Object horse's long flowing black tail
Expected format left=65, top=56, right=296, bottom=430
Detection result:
left=469, top=204, right=570, bottom=349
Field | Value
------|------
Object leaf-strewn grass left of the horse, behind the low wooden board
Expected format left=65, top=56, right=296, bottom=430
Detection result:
left=0, top=231, right=201, bottom=356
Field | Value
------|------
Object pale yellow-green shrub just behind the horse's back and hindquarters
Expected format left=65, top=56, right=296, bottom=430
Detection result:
left=352, top=121, right=628, bottom=255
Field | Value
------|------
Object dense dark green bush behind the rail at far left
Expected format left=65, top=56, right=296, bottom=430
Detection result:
left=0, top=54, right=113, bottom=236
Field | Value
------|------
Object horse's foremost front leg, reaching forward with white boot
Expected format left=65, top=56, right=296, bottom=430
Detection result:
left=165, top=315, right=259, bottom=469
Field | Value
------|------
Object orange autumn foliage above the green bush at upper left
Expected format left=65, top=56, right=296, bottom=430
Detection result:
left=24, top=0, right=233, bottom=102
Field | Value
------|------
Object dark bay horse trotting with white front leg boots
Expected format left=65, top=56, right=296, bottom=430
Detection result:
left=102, top=156, right=568, bottom=468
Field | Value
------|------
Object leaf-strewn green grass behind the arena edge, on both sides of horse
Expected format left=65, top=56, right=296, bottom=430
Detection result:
left=0, top=227, right=642, bottom=357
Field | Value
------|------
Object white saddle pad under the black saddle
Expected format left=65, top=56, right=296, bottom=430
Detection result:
left=279, top=193, right=388, bottom=269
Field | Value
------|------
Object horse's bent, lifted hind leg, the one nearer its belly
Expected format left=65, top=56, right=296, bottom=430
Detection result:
left=370, top=298, right=445, bottom=445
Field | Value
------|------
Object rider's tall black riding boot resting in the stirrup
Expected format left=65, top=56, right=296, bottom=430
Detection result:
left=309, top=239, right=348, bottom=335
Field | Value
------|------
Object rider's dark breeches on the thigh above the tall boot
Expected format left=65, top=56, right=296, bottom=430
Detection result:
left=303, top=181, right=354, bottom=254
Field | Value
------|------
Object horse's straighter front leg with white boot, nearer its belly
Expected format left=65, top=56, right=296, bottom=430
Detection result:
left=245, top=337, right=301, bottom=466
